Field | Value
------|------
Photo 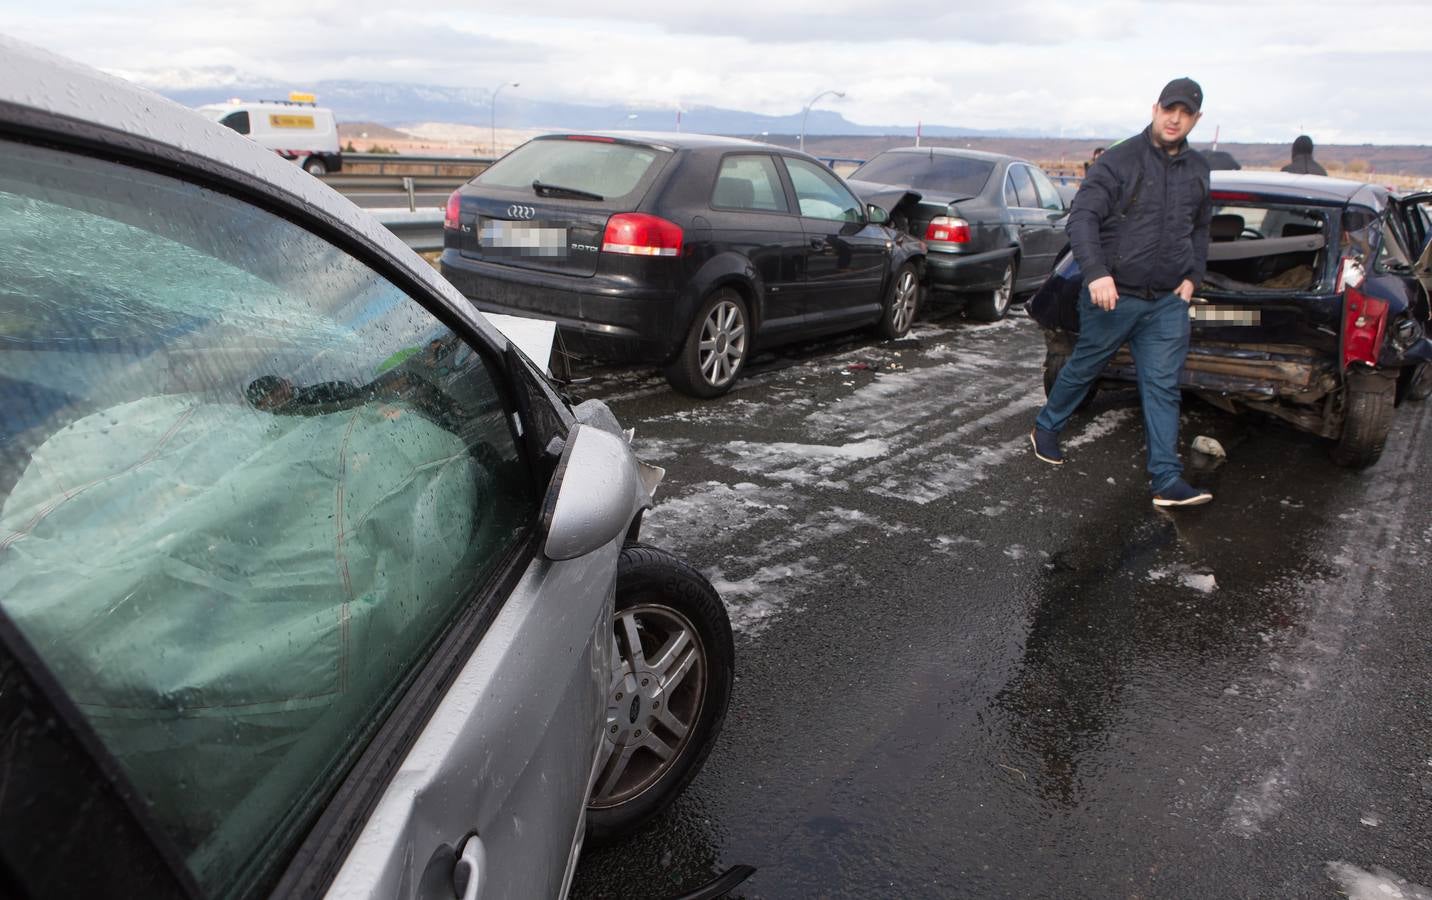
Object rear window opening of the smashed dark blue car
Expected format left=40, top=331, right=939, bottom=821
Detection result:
left=1203, top=203, right=1337, bottom=292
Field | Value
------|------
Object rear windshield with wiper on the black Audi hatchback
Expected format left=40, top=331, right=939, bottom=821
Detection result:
left=474, top=138, right=667, bottom=199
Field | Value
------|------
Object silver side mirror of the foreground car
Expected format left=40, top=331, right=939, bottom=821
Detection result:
left=541, top=424, right=652, bottom=560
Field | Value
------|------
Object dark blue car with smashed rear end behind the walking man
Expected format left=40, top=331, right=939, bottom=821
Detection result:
left=1030, top=171, right=1432, bottom=469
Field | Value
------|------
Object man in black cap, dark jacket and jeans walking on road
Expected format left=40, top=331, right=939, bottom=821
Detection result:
left=1030, top=77, right=1213, bottom=506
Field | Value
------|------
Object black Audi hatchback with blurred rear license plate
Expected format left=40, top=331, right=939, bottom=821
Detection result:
left=440, top=133, right=925, bottom=397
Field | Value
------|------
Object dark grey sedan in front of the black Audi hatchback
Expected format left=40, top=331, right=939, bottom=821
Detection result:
left=851, top=148, right=1068, bottom=321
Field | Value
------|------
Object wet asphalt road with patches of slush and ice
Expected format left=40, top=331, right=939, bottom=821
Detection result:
left=573, top=303, right=1432, bottom=900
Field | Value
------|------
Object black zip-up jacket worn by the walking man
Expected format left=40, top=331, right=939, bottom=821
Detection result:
left=1068, top=128, right=1213, bottom=297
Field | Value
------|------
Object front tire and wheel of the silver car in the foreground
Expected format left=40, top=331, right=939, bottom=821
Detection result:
left=587, top=543, right=736, bottom=844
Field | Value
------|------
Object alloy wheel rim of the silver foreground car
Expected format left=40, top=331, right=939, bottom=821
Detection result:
left=589, top=605, right=706, bottom=808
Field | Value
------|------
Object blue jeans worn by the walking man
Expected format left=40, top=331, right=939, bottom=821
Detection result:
left=1035, top=285, right=1189, bottom=493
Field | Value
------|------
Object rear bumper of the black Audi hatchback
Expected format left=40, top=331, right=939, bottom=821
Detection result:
left=438, top=248, right=684, bottom=364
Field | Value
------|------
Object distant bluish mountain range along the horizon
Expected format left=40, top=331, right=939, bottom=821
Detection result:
left=134, top=69, right=1042, bottom=138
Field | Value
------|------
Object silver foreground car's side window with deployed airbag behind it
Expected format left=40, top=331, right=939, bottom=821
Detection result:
left=0, top=143, right=537, bottom=894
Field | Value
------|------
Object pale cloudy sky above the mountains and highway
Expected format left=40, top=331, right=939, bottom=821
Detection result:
left=0, top=0, right=1432, bottom=143
